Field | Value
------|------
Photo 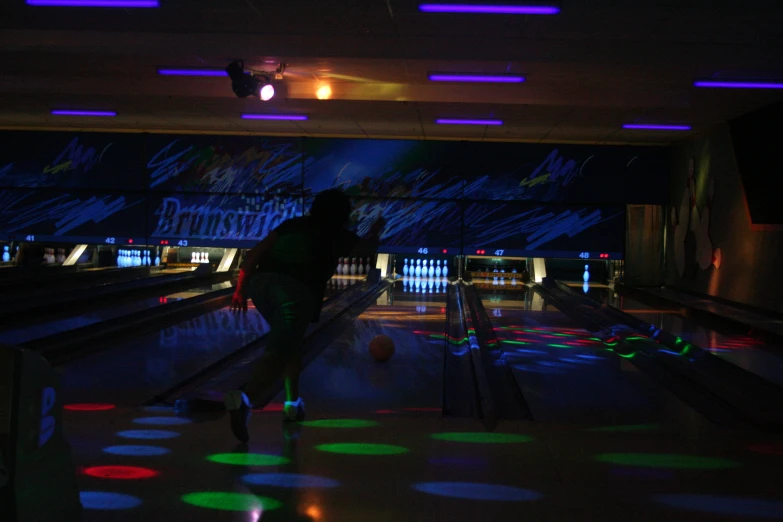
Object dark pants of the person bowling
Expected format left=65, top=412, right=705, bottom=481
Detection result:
left=244, top=273, right=318, bottom=404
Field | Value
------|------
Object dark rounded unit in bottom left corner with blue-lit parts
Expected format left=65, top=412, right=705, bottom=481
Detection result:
left=0, top=344, right=82, bottom=522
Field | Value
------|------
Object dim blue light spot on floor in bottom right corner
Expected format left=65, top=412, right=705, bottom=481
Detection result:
left=653, top=495, right=783, bottom=520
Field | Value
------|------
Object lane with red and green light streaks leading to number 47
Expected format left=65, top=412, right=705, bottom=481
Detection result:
left=480, top=287, right=709, bottom=429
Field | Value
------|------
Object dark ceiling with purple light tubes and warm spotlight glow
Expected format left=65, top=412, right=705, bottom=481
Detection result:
left=0, top=0, right=783, bottom=145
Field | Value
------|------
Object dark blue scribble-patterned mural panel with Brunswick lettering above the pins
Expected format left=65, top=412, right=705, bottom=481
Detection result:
left=0, top=132, right=668, bottom=255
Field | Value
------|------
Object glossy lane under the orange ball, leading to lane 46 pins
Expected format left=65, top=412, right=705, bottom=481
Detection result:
left=294, top=282, right=446, bottom=416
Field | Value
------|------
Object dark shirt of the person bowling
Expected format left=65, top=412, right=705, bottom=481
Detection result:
left=257, top=216, right=360, bottom=304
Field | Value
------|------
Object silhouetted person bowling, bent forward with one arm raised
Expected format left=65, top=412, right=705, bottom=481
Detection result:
left=224, top=189, right=386, bottom=442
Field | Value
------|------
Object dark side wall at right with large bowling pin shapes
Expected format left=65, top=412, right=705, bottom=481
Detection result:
left=665, top=125, right=783, bottom=312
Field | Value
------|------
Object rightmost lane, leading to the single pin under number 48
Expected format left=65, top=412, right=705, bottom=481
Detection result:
left=569, top=284, right=783, bottom=386
